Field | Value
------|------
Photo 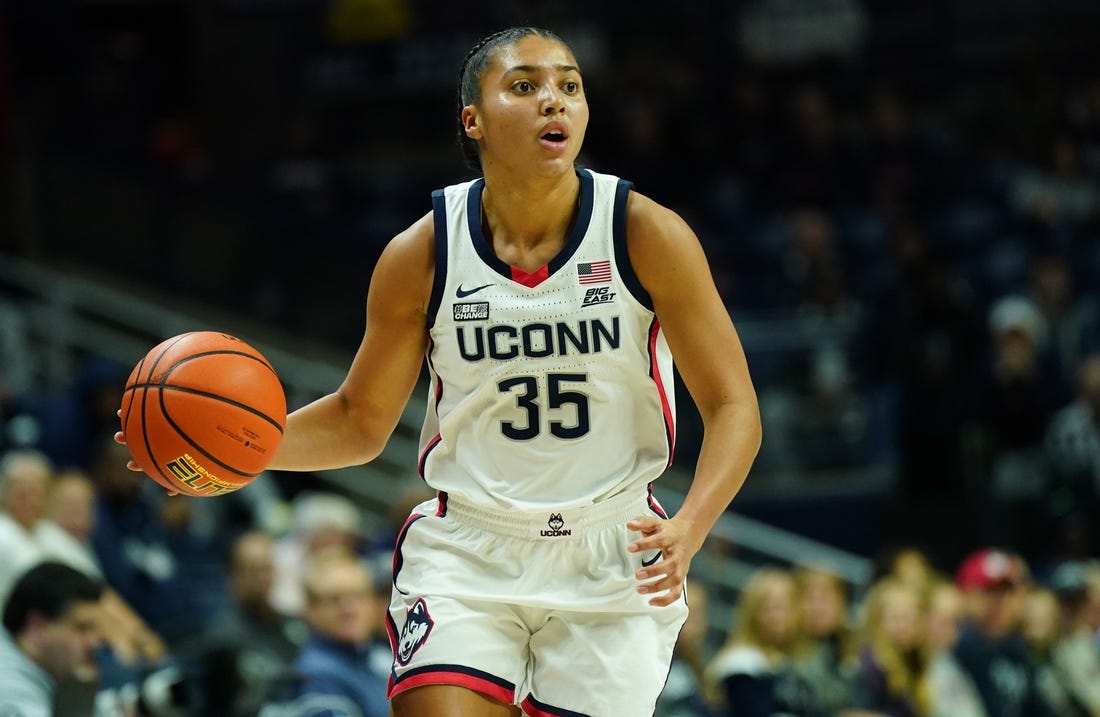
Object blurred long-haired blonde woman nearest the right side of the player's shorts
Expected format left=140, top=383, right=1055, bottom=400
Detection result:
left=706, top=567, right=820, bottom=717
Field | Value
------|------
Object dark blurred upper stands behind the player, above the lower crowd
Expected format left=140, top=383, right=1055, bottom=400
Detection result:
left=0, top=0, right=1100, bottom=712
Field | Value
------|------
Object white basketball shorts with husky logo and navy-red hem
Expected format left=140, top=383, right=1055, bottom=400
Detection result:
left=388, top=483, right=688, bottom=717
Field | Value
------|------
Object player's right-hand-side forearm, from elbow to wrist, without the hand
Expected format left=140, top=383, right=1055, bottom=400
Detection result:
left=677, top=401, right=761, bottom=549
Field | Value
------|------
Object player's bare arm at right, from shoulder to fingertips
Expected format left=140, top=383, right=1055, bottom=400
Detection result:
left=627, top=192, right=761, bottom=605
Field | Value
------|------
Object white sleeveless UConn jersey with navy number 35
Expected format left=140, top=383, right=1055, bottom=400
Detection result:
left=419, top=169, right=675, bottom=510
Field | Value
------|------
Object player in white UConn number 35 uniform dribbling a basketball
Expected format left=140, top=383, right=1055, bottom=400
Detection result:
left=118, top=27, right=760, bottom=717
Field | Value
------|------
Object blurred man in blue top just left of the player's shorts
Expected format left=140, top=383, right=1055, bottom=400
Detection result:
left=281, top=545, right=392, bottom=717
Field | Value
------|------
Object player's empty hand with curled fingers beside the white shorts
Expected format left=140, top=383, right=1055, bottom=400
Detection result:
left=626, top=516, right=700, bottom=606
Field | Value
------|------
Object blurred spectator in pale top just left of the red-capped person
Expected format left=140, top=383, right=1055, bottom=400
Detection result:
left=926, top=577, right=989, bottom=717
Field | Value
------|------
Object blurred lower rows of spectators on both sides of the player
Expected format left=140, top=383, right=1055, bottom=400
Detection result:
left=0, top=435, right=1100, bottom=717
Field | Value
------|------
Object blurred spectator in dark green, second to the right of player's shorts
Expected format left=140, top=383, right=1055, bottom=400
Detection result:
left=794, top=566, right=865, bottom=715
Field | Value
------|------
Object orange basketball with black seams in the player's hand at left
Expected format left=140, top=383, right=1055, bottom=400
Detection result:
left=120, top=331, right=286, bottom=497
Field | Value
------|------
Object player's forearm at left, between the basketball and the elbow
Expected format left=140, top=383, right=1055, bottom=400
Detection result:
left=268, top=393, right=387, bottom=471
